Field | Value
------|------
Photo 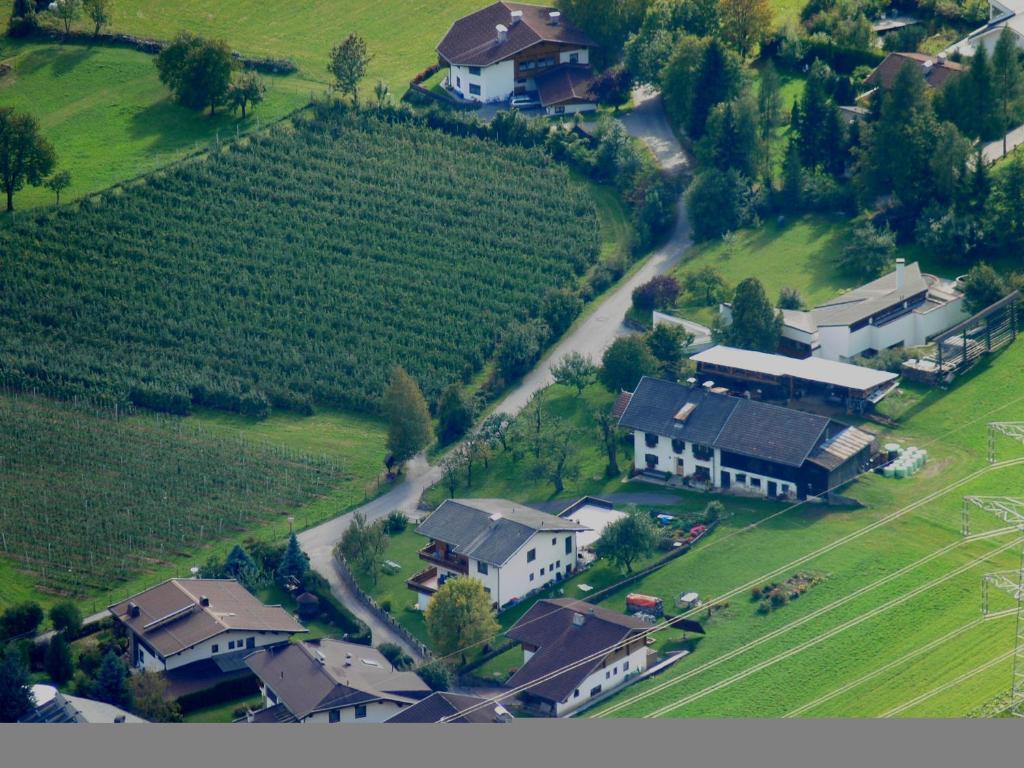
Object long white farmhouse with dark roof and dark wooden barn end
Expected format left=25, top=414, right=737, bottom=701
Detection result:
left=618, top=377, right=877, bottom=499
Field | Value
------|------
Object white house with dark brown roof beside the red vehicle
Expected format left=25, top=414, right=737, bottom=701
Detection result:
left=505, top=598, right=649, bottom=717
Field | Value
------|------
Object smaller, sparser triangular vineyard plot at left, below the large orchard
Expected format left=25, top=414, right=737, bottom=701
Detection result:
left=0, top=396, right=344, bottom=595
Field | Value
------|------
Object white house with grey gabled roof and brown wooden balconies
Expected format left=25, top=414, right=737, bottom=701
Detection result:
left=406, top=499, right=588, bottom=609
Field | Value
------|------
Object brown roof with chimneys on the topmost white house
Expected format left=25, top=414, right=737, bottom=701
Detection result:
left=437, top=2, right=595, bottom=67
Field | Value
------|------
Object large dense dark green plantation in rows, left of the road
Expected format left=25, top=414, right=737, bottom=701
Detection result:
left=0, top=113, right=599, bottom=415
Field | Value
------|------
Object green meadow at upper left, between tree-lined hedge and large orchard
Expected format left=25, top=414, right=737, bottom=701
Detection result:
left=0, top=40, right=309, bottom=209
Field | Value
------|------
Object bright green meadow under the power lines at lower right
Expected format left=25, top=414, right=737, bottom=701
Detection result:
left=594, top=344, right=1024, bottom=717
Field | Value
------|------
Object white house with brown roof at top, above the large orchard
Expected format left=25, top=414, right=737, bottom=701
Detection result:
left=437, top=2, right=597, bottom=114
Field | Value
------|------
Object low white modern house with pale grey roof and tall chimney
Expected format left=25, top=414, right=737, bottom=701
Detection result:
left=721, top=259, right=968, bottom=361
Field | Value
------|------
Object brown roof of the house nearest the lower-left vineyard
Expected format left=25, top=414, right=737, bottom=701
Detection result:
left=108, top=579, right=307, bottom=658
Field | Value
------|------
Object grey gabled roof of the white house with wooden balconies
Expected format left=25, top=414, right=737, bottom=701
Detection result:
left=416, top=499, right=587, bottom=565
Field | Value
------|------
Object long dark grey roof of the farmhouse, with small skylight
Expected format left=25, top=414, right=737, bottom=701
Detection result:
left=618, top=377, right=829, bottom=467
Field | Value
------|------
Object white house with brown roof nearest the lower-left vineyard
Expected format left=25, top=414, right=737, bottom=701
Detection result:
left=108, top=579, right=307, bottom=672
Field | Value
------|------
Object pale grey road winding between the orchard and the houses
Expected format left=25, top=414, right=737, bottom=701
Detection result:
left=298, top=89, right=691, bottom=660
